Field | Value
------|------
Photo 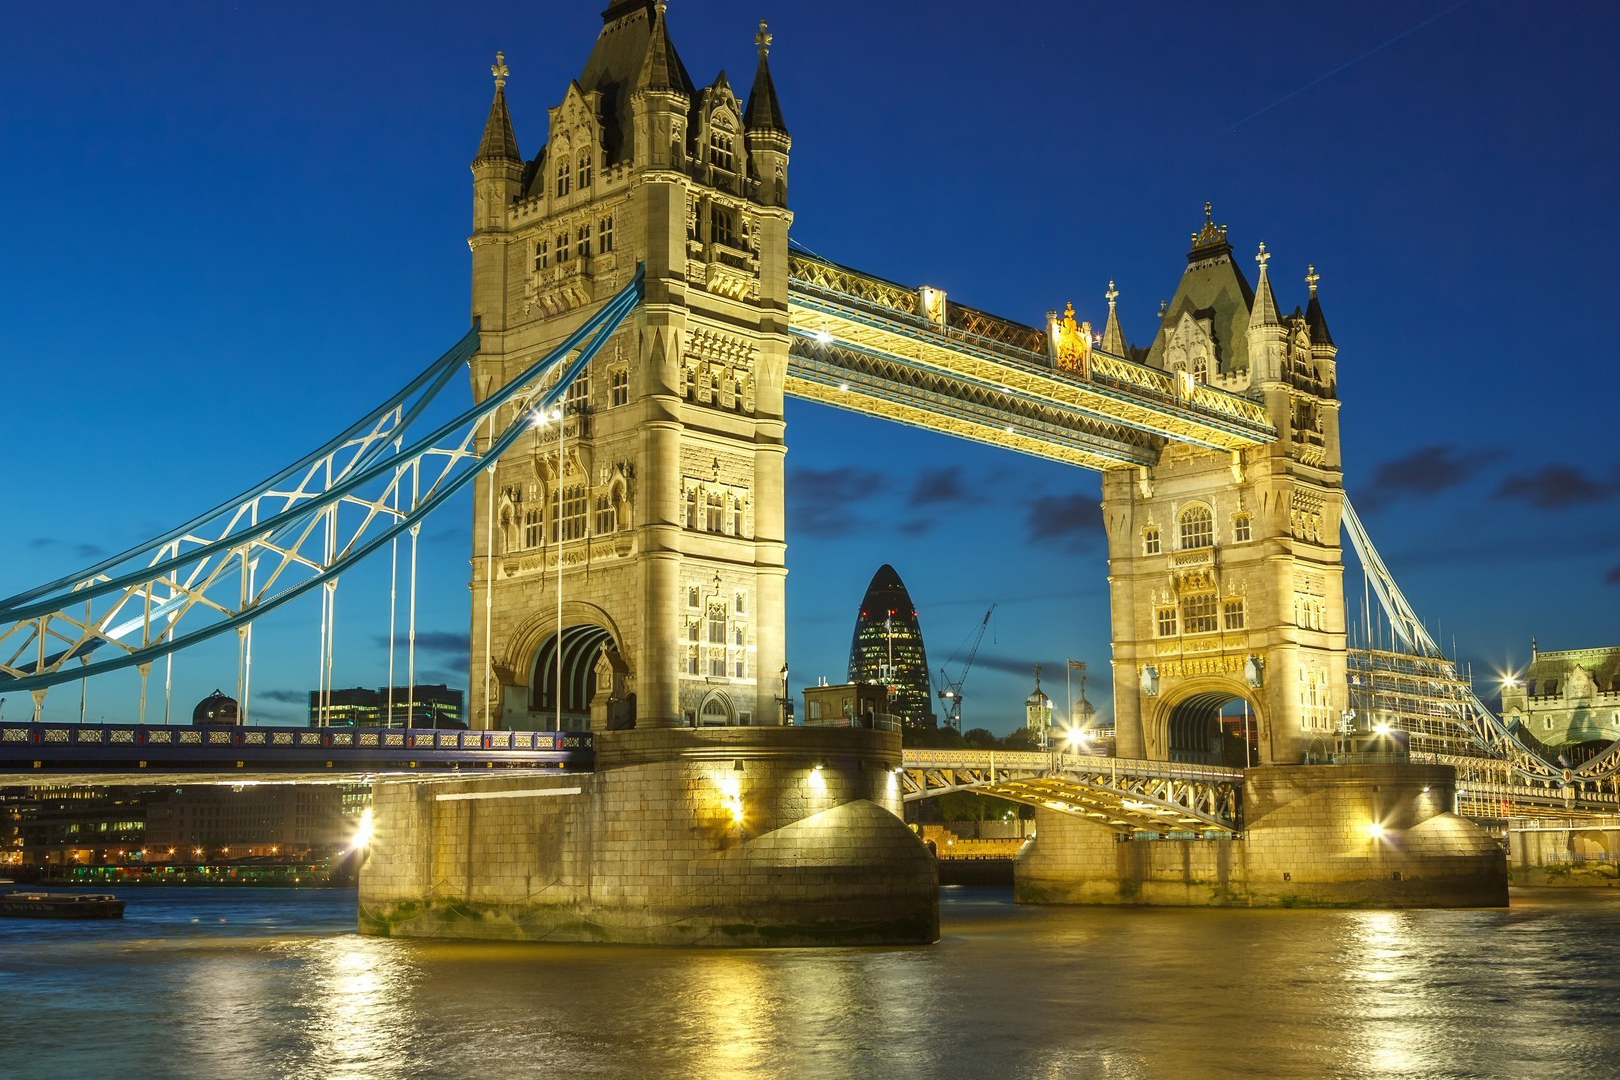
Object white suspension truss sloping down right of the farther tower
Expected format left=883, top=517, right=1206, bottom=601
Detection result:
left=1345, top=497, right=1620, bottom=793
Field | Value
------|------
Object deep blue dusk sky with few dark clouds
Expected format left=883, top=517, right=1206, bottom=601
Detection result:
left=0, top=0, right=1620, bottom=730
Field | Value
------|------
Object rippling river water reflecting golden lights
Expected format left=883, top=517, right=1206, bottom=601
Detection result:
left=0, top=887, right=1620, bottom=1080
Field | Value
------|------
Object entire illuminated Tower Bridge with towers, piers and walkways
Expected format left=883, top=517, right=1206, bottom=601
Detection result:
left=0, top=0, right=1600, bottom=944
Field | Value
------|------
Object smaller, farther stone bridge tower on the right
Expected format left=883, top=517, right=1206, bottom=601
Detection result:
left=1103, top=206, right=1348, bottom=766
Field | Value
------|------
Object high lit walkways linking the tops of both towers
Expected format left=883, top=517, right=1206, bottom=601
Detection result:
left=786, top=251, right=1277, bottom=470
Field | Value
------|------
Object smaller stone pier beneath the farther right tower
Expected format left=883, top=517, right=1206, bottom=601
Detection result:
left=1014, top=764, right=1508, bottom=907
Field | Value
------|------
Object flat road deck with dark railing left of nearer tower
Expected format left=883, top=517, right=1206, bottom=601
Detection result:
left=0, top=722, right=596, bottom=785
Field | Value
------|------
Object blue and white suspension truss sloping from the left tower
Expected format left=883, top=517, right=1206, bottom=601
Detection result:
left=0, top=270, right=642, bottom=704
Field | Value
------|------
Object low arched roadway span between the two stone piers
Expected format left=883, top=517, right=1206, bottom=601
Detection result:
left=901, top=750, right=1243, bottom=834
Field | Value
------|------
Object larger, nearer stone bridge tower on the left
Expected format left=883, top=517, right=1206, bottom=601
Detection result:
left=468, top=0, right=792, bottom=729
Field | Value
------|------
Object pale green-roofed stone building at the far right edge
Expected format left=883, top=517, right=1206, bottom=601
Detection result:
left=1502, top=638, right=1620, bottom=746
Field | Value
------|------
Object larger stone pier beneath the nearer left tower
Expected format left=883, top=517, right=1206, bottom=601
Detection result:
left=360, top=727, right=940, bottom=946
